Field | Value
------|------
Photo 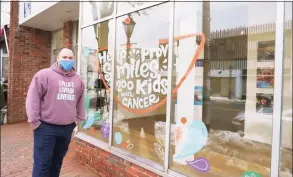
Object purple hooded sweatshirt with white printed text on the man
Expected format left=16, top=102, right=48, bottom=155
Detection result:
left=26, top=63, right=85, bottom=128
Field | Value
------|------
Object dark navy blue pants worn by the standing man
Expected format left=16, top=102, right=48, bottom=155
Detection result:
left=32, top=122, right=76, bottom=177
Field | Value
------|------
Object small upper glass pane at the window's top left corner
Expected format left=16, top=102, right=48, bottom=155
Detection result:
left=82, top=1, right=114, bottom=25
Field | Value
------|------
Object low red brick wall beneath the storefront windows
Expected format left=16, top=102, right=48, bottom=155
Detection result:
left=74, top=138, right=159, bottom=177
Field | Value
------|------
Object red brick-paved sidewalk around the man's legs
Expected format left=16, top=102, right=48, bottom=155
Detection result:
left=1, top=122, right=98, bottom=177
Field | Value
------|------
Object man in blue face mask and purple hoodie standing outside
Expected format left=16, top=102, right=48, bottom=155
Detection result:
left=26, top=48, right=85, bottom=177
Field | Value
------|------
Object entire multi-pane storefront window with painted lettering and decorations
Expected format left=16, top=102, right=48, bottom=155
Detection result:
left=79, top=1, right=293, bottom=177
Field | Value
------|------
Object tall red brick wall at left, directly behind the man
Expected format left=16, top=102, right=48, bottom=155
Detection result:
left=7, top=1, right=51, bottom=123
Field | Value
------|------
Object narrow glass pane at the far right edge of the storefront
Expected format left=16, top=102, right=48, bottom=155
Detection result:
left=280, top=2, right=293, bottom=177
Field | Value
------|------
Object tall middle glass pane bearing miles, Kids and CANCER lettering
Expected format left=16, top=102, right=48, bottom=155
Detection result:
left=113, top=4, right=169, bottom=163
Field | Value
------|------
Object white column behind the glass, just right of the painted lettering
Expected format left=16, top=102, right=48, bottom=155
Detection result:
left=174, top=20, right=197, bottom=165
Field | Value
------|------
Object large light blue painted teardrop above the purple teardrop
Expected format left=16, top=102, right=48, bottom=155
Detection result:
left=174, top=120, right=208, bottom=159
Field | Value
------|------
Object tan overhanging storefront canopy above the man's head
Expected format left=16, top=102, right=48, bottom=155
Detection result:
left=20, top=2, right=79, bottom=31
